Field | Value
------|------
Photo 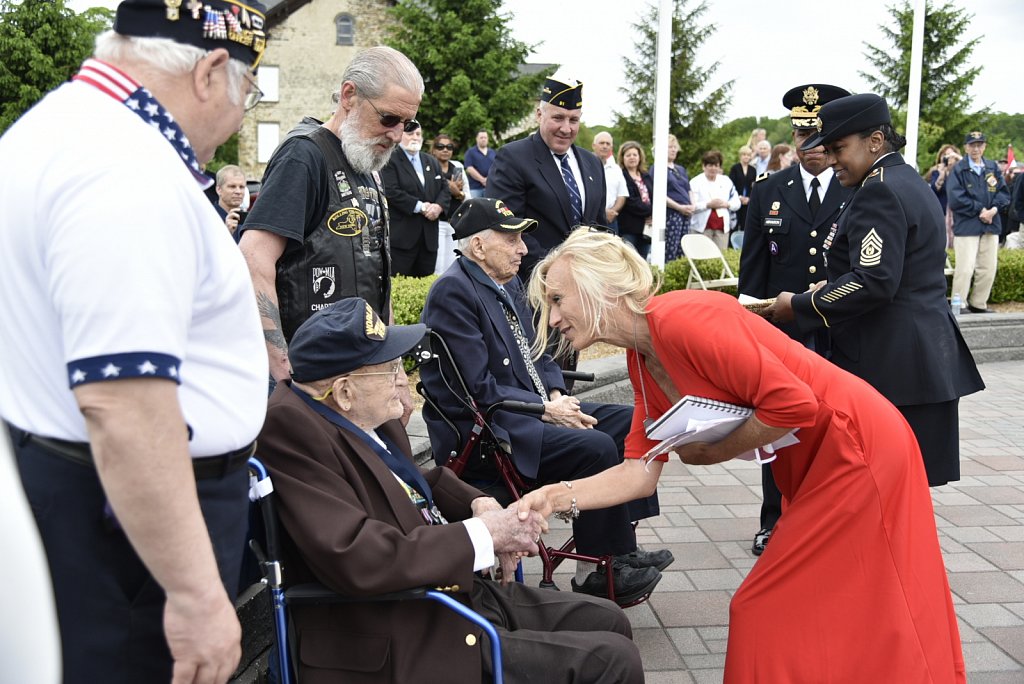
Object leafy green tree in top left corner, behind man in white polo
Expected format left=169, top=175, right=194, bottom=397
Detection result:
left=0, top=0, right=114, bottom=132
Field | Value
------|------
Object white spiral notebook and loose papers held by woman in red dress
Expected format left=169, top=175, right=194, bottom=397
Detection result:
left=643, top=394, right=800, bottom=463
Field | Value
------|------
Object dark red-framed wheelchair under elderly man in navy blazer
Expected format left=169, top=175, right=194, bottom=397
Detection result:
left=405, top=329, right=650, bottom=608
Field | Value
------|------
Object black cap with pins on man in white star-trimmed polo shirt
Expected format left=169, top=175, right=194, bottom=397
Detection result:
left=114, top=0, right=266, bottom=70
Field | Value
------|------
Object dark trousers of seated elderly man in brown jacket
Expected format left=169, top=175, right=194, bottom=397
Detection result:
left=471, top=579, right=644, bottom=684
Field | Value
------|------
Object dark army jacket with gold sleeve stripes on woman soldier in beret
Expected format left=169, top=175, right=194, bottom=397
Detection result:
left=793, top=153, right=984, bottom=407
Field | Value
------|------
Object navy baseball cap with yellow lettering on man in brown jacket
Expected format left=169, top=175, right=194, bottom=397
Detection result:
left=288, top=297, right=427, bottom=382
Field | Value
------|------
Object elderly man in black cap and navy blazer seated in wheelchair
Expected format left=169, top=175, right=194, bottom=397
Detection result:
left=420, top=198, right=674, bottom=605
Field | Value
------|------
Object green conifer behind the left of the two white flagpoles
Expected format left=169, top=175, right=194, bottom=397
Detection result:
left=615, top=0, right=733, bottom=166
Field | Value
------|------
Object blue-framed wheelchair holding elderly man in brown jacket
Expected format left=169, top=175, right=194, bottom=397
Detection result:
left=249, top=458, right=504, bottom=684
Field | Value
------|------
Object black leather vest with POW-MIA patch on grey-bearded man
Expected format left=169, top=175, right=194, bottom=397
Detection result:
left=278, top=127, right=391, bottom=340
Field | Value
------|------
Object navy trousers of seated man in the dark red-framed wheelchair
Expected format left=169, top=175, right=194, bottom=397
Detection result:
left=532, top=403, right=657, bottom=555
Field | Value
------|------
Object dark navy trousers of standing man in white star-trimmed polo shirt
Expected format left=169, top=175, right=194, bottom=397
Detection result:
left=12, top=431, right=249, bottom=684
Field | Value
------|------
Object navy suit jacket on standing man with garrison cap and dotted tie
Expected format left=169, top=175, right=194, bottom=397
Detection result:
left=483, top=133, right=607, bottom=274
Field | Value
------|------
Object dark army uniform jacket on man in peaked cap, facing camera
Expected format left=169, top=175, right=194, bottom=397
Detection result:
left=739, top=165, right=852, bottom=339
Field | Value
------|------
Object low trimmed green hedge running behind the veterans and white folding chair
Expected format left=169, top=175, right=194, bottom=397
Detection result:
left=391, top=249, right=1024, bottom=326
